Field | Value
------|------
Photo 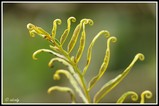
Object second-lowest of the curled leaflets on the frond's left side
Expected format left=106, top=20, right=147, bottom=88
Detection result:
left=53, top=69, right=88, bottom=103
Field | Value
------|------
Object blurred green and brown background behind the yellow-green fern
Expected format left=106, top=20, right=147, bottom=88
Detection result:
left=2, top=3, right=156, bottom=103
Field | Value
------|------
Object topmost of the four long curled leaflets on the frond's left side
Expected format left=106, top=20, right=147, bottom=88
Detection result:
left=32, top=49, right=67, bottom=60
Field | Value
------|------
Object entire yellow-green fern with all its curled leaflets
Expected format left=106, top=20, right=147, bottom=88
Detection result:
left=27, top=17, right=152, bottom=103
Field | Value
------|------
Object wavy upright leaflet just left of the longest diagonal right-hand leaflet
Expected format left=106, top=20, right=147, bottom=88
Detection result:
left=88, top=37, right=117, bottom=91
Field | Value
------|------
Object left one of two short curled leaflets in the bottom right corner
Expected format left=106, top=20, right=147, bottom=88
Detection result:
left=117, top=91, right=138, bottom=104
